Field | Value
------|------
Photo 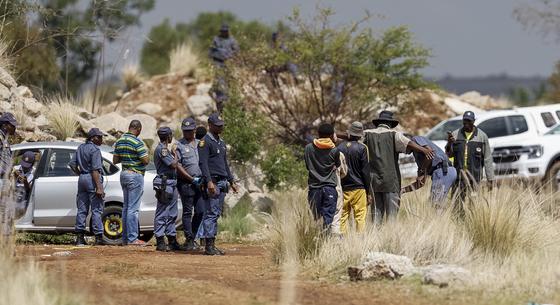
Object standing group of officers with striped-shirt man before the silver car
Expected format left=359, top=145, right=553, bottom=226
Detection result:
left=72, top=113, right=237, bottom=255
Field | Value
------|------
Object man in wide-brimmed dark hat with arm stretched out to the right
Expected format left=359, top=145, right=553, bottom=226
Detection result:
left=364, top=110, right=434, bottom=225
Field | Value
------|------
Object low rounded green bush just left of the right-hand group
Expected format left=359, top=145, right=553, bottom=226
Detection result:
left=261, top=144, right=307, bottom=190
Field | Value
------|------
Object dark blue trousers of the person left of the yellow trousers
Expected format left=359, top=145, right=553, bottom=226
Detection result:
left=307, top=186, right=338, bottom=228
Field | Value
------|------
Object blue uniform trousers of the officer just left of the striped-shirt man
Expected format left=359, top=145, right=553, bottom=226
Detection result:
left=74, top=174, right=104, bottom=235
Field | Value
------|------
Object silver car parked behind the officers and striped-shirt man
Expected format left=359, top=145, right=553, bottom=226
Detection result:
left=12, top=142, right=181, bottom=244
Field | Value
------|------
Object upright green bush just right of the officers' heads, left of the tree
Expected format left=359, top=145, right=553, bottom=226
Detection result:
left=223, top=95, right=267, bottom=163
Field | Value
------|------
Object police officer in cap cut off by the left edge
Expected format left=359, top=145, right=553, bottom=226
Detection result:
left=0, top=112, right=17, bottom=194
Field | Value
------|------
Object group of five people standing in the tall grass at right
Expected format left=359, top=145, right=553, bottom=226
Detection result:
left=304, top=111, right=494, bottom=234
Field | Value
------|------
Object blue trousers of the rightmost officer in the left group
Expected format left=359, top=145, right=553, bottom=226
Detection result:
left=196, top=181, right=227, bottom=238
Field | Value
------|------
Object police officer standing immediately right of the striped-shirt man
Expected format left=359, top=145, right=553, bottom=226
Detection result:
left=153, top=127, right=194, bottom=251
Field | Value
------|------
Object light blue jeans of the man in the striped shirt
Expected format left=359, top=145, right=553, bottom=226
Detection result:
left=121, top=170, right=144, bottom=244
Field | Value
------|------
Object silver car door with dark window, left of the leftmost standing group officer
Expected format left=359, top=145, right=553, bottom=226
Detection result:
left=33, top=148, right=78, bottom=228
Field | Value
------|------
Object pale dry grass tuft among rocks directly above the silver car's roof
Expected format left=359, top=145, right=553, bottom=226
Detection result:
left=45, top=96, right=78, bottom=141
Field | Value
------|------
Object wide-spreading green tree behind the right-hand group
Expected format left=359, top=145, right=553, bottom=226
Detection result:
left=230, top=9, right=430, bottom=144
